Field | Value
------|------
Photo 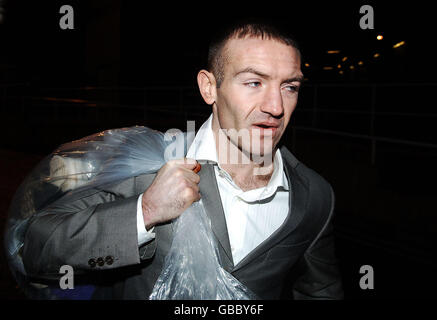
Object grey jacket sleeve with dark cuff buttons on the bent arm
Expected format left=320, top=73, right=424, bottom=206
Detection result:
left=22, top=178, right=156, bottom=277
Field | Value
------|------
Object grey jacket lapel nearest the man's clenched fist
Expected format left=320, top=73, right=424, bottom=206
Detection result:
left=199, top=164, right=234, bottom=270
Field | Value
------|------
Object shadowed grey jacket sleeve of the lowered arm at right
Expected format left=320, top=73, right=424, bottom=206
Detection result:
left=293, top=188, right=344, bottom=300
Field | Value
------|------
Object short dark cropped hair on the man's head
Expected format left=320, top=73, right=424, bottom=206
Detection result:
left=207, top=20, right=300, bottom=88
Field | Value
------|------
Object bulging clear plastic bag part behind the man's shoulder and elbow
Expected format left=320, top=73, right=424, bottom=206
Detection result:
left=4, top=127, right=171, bottom=299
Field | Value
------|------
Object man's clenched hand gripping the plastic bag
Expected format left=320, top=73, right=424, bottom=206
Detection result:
left=142, top=158, right=200, bottom=230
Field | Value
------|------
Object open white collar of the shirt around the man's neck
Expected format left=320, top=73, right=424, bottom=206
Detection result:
left=187, top=114, right=289, bottom=198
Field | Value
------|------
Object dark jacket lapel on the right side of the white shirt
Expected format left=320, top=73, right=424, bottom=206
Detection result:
left=232, top=148, right=309, bottom=272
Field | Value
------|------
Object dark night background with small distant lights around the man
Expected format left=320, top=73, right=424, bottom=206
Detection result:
left=0, top=0, right=437, bottom=299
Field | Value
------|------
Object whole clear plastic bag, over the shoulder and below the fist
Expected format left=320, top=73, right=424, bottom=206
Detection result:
left=5, top=127, right=256, bottom=299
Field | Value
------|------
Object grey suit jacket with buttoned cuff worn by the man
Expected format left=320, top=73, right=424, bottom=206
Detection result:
left=23, top=147, right=343, bottom=299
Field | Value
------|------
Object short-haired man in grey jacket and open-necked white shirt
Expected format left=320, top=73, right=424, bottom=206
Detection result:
left=23, top=24, right=343, bottom=299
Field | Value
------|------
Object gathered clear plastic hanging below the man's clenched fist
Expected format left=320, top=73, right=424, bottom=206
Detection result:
left=149, top=200, right=256, bottom=300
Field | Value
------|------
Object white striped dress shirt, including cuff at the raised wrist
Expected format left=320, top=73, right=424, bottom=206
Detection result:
left=137, top=115, right=289, bottom=265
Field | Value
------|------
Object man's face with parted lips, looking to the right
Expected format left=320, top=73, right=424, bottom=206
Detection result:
left=213, top=38, right=303, bottom=159
